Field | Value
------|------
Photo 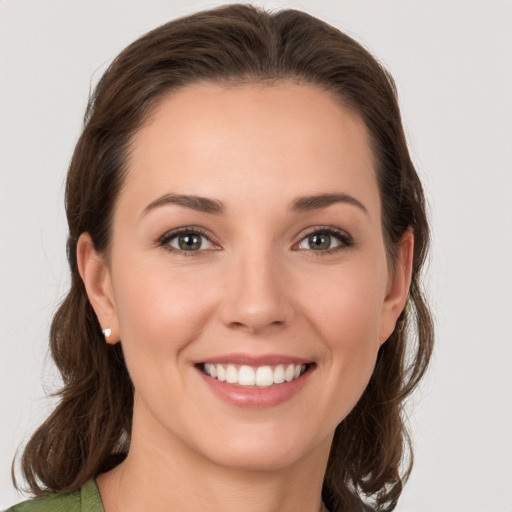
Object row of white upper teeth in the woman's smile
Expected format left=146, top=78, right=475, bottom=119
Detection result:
left=203, top=363, right=306, bottom=388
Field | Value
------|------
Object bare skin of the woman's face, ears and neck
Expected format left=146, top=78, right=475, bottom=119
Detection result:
left=78, top=83, right=413, bottom=512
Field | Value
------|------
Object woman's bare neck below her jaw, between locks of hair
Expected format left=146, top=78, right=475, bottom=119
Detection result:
left=97, top=398, right=331, bottom=512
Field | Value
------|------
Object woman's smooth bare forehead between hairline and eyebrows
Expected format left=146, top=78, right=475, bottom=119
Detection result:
left=120, top=83, right=379, bottom=219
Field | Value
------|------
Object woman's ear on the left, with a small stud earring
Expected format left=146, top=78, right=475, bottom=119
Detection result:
left=76, top=233, right=119, bottom=345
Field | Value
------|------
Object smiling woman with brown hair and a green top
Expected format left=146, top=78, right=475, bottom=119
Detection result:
left=11, top=5, right=432, bottom=512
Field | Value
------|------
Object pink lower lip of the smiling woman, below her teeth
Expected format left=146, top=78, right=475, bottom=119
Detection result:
left=197, top=368, right=313, bottom=409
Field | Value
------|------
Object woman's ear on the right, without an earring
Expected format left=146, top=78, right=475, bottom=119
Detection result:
left=379, top=229, right=414, bottom=344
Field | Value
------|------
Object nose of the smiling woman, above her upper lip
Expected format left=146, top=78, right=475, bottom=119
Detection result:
left=221, top=246, right=294, bottom=334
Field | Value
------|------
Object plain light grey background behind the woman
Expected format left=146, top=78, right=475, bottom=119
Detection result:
left=0, top=0, right=512, bottom=512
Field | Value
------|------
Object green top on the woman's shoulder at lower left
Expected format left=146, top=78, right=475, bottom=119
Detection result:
left=5, top=480, right=105, bottom=512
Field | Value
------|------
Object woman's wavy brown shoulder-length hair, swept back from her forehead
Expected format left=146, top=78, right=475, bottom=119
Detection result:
left=15, top=5, right=433, bottom=511
